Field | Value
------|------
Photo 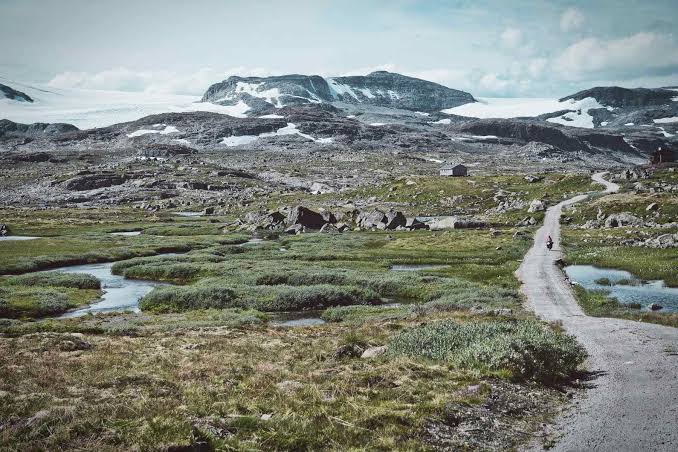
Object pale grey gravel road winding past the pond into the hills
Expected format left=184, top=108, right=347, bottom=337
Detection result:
left=517, top=173, right=678, bottom=451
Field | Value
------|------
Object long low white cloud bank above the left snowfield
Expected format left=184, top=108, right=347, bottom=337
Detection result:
left=48, top=67, right=271, bottom=96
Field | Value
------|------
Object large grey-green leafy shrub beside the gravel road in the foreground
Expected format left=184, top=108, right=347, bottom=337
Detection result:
left=389, top=321, right=586, bottom=383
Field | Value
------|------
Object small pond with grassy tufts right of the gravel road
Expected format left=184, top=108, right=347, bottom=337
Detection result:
left=565, top=265, right=678, bottom=312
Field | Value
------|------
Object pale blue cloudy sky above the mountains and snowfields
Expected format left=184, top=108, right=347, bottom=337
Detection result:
left=0, top=0, right=678, bottom=97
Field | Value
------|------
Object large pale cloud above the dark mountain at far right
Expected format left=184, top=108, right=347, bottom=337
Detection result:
left=554, top=32, right=678, bottom=80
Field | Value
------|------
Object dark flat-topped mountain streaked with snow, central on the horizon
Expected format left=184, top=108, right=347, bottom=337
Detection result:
left=202, top=71, right=475, bottom=113
